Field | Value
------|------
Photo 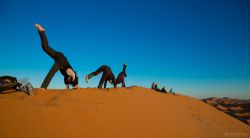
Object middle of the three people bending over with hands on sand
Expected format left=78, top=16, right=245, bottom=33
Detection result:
left=85, top=65, right=116, bottom=88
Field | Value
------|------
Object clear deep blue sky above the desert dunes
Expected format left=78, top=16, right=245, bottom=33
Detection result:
left=0, top=0, right=250, bottom=98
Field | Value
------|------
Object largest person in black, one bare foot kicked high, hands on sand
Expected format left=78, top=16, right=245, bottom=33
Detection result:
left=35, top=24, right=80, bottom=89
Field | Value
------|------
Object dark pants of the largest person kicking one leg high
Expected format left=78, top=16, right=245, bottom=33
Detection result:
left=39, top=31, right=68, bottom=89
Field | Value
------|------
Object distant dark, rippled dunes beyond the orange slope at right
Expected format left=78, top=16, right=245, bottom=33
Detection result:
left=202, top=97, right=250, bottom=126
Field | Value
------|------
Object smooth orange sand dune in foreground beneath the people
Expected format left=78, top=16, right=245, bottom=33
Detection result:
left=0, top=87, right=250, bottom=138
